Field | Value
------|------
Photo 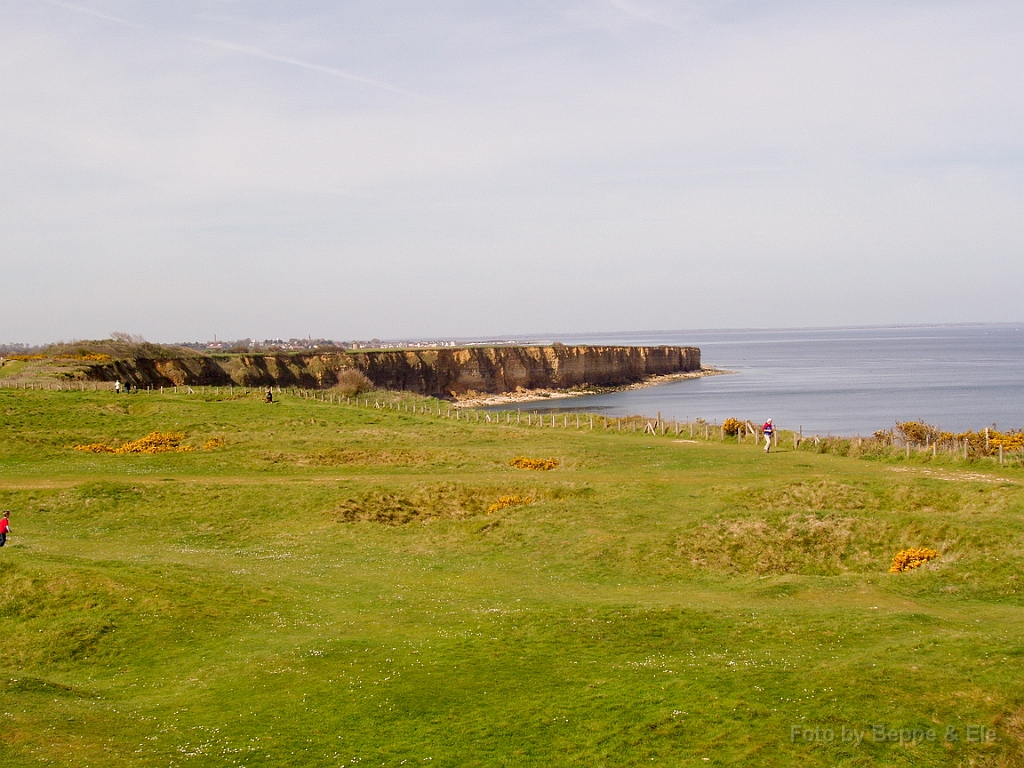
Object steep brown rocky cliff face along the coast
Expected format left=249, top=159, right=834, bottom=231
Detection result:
left=90, top=345, right=700, bottom=397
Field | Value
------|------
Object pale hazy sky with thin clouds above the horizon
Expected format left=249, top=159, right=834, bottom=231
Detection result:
left=0, top=0, right=1024, bottom=343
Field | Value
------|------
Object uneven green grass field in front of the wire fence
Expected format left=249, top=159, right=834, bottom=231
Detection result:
left=0, top=390, right=1024, bottom=767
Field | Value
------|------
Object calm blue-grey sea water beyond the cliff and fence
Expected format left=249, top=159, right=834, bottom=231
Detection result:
left=483, top=325, right=1024, bottom=435
